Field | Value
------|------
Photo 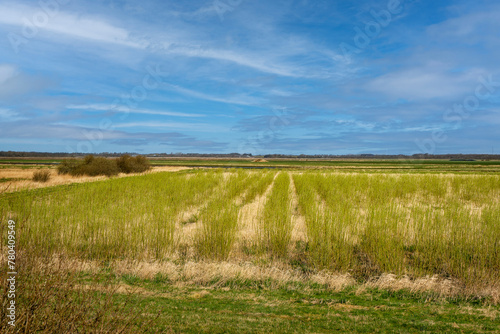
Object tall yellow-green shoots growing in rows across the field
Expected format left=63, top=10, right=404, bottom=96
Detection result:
left=0, top=170, right=500, bottom=285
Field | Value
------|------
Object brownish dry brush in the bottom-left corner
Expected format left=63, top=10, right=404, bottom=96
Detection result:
left=0, top=253, right=159, bottom=333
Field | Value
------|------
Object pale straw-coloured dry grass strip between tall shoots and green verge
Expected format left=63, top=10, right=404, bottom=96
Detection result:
left=41, top=256, right=500, bottom=304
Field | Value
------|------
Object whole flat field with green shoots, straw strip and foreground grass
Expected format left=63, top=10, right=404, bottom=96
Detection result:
left=0, top=161, right=500, bottom=333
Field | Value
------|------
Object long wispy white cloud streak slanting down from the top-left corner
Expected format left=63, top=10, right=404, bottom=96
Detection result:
left=0, top=3, right=344, bottom=78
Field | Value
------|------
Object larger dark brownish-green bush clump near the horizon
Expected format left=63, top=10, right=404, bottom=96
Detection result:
left=57, top=154, right=151, bottom=176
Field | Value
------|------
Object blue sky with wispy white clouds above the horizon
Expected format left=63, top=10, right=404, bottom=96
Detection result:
left=0, top=0, right=500, bottom=154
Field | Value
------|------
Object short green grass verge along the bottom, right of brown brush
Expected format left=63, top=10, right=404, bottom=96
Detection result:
left=78, top=276, right=500, bottom=333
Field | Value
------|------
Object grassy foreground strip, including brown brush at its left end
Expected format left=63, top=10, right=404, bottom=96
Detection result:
left=0, top=254, right=500, bottom=333
